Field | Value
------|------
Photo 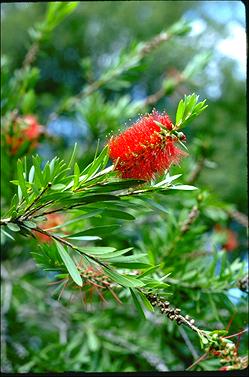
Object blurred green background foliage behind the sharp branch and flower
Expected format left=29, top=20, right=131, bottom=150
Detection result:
left=1, top=1, right=247, bottom=372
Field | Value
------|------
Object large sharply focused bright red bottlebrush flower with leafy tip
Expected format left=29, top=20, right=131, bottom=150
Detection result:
left=108, top=111, right=186, bottom=181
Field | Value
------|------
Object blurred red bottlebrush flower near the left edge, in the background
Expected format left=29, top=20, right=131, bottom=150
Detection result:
left=6, top=115, right=44, bottom=155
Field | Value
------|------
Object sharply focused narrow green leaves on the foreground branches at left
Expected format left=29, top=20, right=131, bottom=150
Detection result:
left=1, top=125, right=199, bottom=303
